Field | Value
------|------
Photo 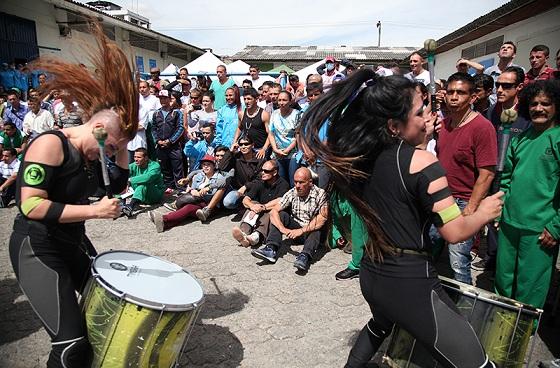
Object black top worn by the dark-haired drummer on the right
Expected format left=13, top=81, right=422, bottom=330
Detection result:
left=364, top=141, right=439, bottom=250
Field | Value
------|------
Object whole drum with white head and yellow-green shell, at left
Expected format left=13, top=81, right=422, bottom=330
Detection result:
left=83, top=251, right=204, bottom=368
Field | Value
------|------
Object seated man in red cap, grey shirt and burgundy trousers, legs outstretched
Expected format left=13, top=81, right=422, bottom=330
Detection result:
left=150, top=155, right=226, bottom=233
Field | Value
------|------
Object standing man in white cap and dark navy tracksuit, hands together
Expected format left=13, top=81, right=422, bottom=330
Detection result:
left=152, top=89, right=184, bottom=193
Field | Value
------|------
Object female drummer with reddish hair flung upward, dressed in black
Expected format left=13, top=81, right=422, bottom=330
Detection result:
left=10, top=25, right=138, bottom=368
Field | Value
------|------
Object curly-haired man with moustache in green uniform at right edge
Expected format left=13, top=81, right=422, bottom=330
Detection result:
left=495, top=81, right=560, bottom=308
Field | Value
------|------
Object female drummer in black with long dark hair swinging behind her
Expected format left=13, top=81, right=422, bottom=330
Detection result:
left=302, top=69, right=502, bottom=368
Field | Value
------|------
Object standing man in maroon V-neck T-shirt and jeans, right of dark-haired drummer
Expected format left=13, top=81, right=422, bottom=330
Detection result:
left=436, top=73, right=498, bottom=284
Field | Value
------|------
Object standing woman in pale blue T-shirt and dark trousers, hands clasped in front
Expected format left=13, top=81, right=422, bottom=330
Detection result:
left=268, top=91, right=299, bottom=187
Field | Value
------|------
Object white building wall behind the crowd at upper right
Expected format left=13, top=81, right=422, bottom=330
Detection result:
left=435, top=6, right=560, bottom=79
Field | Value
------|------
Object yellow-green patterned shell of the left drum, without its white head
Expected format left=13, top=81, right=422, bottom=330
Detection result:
left=83, top=277, right=198, bottom=368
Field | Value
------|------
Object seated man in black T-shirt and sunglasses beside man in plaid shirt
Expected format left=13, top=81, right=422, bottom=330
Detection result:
left=232, top=160, right=290, bottom=247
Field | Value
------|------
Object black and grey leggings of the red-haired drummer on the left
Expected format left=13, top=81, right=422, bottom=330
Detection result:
left=10, top=215, right=96, bottom=368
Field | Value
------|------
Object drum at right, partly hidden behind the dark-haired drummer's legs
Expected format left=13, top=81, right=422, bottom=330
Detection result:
left=383, top=276, right=542, bottom=368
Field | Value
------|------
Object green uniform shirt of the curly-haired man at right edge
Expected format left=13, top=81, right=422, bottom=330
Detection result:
left=500, top=126, right=560, bottom=239
